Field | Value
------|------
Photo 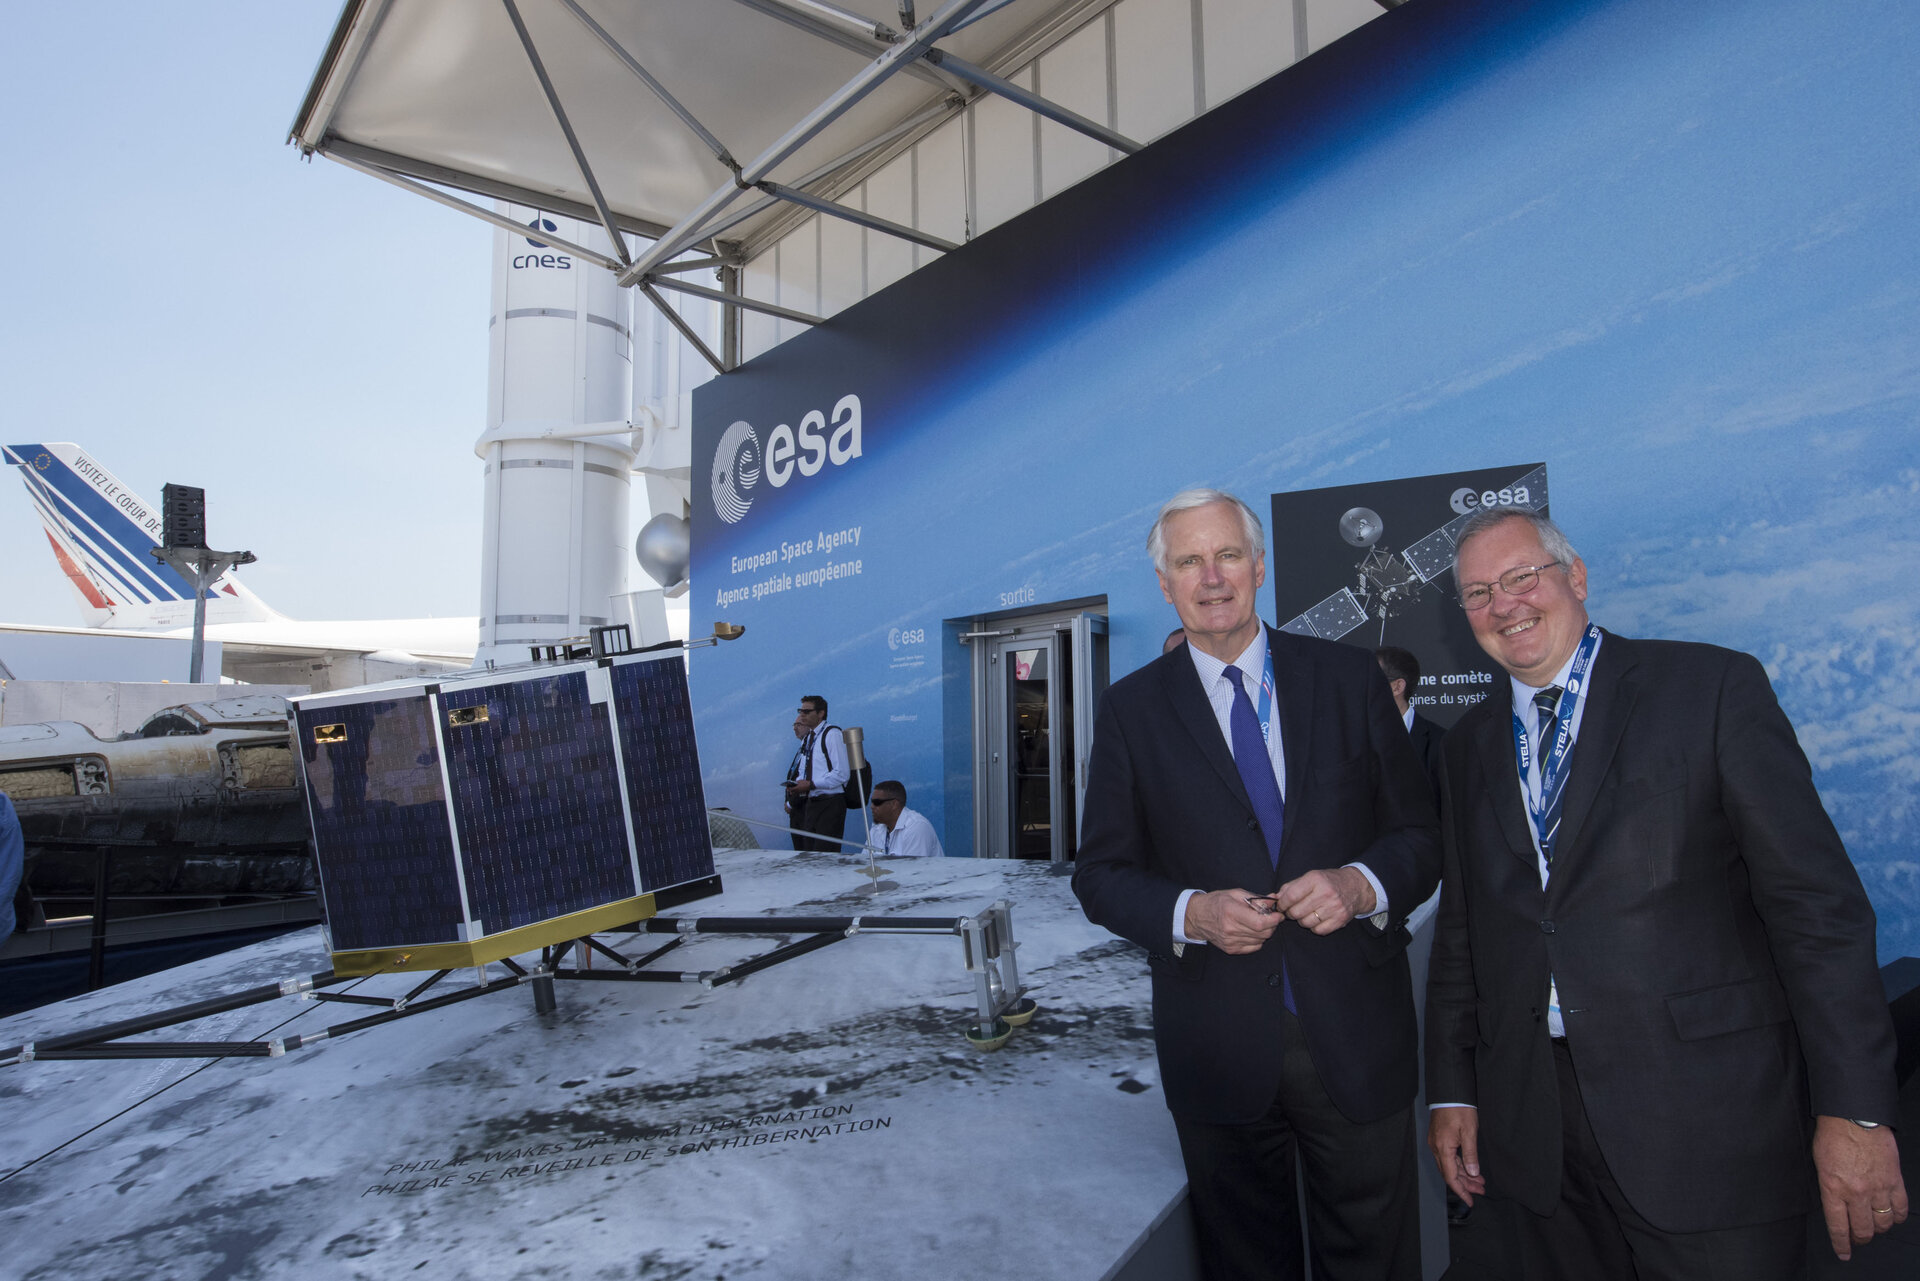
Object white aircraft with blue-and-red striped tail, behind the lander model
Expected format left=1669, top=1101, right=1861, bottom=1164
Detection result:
left=0, top=444, right=478, bottom=691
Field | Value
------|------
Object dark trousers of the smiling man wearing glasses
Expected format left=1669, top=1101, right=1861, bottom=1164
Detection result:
left=1473, top=1041, right=1807, bottom=1281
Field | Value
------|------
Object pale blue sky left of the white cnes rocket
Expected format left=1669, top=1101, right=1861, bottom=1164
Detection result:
left=0, top=0, right=492, bottom=626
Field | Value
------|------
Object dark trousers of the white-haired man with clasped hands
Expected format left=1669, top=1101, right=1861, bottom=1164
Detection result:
left=1173, top=1012, right=1421, bottom=1281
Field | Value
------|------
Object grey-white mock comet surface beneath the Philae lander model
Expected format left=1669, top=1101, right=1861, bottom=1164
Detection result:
left=0, top=851, right=1185, bottom=1281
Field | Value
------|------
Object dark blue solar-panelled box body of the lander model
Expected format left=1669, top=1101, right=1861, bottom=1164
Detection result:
left=294, top=651, right=720, bottom=974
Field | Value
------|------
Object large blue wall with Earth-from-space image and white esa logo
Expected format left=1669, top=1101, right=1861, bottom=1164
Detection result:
left=693, top=0, right=1920, bottom=958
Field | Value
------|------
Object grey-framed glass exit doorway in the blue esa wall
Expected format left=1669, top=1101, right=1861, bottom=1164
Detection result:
left=962, top=597, right=1106, bottom=862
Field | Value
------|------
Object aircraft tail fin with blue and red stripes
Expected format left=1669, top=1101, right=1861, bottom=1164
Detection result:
left=0, top=442, right=280, bottom=630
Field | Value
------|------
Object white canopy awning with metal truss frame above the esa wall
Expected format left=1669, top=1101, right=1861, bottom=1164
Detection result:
left=292, top=0, right=1402, bottom=367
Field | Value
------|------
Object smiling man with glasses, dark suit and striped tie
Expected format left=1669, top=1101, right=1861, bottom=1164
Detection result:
left=1427, top=509, right=1907, bottom=1281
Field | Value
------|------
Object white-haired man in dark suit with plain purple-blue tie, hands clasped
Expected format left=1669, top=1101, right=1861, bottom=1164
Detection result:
left=1073, top=490, right=1438, bottom=1281
